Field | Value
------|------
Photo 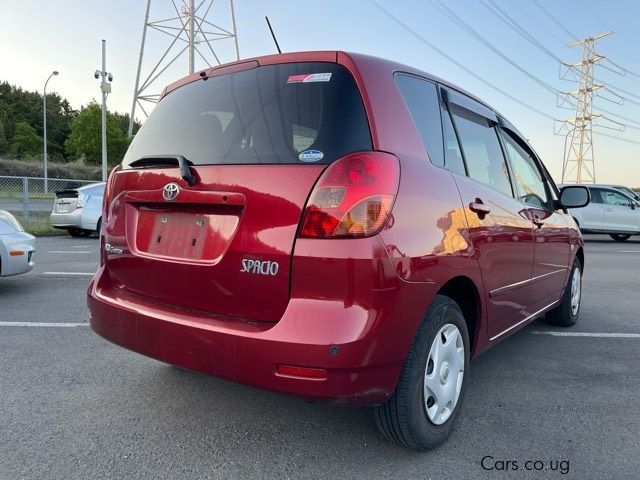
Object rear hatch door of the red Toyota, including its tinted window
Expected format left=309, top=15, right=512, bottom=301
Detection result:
left=104, top=62, right=371, bottom=322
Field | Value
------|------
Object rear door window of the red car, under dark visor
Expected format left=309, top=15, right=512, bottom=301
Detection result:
left=450, top=104, right=513, bottom=197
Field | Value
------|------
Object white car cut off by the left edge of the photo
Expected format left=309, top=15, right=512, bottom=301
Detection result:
left=0, top=210, right=36, bottom=277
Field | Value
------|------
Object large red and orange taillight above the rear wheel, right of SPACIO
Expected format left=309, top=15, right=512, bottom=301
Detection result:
left=300, top=152, right=400, bottom=238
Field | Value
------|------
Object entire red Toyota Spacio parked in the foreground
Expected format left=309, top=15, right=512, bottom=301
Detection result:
left=88, top=51, right=589, bottom=450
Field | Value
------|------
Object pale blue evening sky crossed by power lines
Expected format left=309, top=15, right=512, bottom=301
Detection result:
left=0, top=0, right=640, bottom=187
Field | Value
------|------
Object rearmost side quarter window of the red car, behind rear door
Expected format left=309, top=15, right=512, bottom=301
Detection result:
left=395, top=74, right=444, bottom=167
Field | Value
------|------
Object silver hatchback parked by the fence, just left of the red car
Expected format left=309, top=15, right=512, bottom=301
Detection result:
left=50, top=182, right=105, bottom=237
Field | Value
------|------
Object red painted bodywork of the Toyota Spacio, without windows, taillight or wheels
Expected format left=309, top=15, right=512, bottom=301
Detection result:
left=88, top=52, right=583, bottom=405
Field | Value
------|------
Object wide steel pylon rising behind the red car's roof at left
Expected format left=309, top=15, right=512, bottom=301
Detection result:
left=128, top=0, right=240, bottom=136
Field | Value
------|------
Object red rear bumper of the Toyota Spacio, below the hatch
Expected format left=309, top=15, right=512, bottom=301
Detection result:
left=88, top=255, right=435, bottom=405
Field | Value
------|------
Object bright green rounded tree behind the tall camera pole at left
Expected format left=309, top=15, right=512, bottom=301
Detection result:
left=65, top=102, right=129, bottom=165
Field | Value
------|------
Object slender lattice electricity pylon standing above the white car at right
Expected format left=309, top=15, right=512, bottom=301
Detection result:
left=556, top=32, right=624, bottom=184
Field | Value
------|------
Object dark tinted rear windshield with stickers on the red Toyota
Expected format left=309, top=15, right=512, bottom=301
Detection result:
left=122, top=62, right=371, bottom=168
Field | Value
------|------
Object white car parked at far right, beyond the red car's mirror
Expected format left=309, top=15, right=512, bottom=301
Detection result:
left=571, top=185, right=640, bottom=242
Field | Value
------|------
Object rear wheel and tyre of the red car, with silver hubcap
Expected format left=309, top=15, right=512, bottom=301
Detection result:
left=374, top=295, right=469, bottom=451
